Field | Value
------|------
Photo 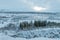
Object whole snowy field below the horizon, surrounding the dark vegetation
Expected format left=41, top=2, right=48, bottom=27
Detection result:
left=0, top=13, right=60, bottom=40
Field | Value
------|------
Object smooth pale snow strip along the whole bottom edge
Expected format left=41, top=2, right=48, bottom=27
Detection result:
left=0, top=33, right=60, bottom=40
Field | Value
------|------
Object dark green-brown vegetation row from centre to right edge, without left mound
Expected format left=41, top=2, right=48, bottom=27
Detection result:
left=20, top=21, right=60, bottom=29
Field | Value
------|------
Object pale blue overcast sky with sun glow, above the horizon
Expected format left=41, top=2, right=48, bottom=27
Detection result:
left=0, top=0, right=60, bottom=12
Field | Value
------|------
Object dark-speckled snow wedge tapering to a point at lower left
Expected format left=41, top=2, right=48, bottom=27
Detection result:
left=10, top=28, right=60, bottom=39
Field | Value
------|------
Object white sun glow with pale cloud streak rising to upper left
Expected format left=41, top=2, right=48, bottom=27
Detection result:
left=22, top=0, right=46, bottom=12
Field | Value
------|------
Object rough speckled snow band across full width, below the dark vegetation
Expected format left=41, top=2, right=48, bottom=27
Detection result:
left=0, top=24, right=60, bottom=39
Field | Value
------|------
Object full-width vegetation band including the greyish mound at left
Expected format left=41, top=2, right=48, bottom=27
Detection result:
left=0, top=20, right=60, bottom=30
